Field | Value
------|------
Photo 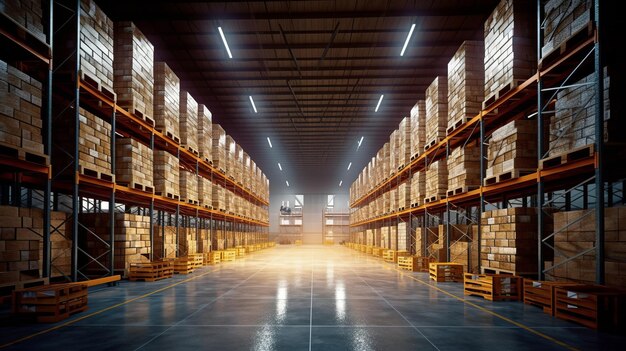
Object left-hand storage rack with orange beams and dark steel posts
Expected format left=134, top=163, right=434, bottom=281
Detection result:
left=0, top=0, right=269, bottom=281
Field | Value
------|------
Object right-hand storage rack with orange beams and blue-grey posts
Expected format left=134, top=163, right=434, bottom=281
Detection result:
left=350, top=0, right=624, bottom=284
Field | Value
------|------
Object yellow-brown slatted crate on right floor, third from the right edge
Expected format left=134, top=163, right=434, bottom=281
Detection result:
left=463, top=273, right=524, bottom=301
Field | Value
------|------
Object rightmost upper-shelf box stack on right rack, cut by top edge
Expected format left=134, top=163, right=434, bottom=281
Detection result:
left=541, top=0, right=593, bottom=57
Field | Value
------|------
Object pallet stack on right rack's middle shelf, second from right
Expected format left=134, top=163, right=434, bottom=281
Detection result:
left=484, top=119, right=537, bottom=185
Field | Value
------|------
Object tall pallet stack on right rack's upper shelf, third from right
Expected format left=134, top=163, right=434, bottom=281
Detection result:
left=446, top=40, right=485, bottom=134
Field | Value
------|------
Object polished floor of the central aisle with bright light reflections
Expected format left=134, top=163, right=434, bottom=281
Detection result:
left=0, top=245, right=626, bottom=351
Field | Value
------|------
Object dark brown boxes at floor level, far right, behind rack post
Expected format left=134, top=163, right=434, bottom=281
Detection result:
left=546, top=207, right=626, bottom=288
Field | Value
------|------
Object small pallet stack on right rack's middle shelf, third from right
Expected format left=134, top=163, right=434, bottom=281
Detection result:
left=447, top=140, right=481, bottom=196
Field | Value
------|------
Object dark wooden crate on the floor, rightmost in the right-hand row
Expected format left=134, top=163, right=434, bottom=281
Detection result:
left=555, top=285, right=626, bottom=333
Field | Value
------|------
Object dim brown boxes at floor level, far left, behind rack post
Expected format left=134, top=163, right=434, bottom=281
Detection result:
left=0, top=206, right=72, bottom=284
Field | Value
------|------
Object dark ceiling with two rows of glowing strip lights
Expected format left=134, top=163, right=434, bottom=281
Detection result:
left=98, top=0, right=498, bottom=193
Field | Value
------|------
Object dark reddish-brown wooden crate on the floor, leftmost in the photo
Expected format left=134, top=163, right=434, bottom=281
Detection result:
left=12, top=283, right=88, bottom=323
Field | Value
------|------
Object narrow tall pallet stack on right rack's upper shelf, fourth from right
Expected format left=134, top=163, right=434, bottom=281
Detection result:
left=424, top=76, right=448, bottom=150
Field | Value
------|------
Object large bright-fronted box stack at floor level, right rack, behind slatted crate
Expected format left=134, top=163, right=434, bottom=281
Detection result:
left=480, top=207, right=552, bottom=275
